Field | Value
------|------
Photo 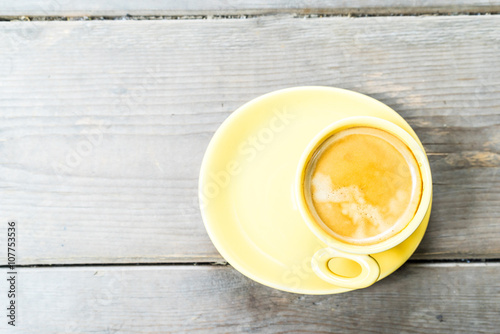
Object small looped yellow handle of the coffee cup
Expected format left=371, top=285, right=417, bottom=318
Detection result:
left=311, top=248, right=380, bottom=289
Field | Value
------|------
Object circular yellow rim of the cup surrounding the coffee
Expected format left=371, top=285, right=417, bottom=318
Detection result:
left=295, top=116, right=432, bottom=254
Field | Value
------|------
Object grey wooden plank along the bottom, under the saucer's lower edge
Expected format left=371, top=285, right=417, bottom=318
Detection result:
left=0, top=264, right=500, bottom=334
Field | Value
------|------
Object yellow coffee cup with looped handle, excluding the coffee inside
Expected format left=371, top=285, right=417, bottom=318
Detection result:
left=294, top=116, right=432, bottom=289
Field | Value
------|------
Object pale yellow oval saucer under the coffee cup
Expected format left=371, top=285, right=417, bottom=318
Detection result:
left=199, top=87, right=431, bottom=294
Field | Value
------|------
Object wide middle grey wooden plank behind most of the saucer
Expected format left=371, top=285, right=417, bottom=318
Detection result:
left=0, top=16, right=500, bottom=264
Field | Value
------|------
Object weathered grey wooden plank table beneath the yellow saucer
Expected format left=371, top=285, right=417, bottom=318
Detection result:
left=0, top=0, right=500, bottom=333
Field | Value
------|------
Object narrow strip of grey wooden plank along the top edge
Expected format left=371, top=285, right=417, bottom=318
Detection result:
left=0, top=0, right=500, bottom=17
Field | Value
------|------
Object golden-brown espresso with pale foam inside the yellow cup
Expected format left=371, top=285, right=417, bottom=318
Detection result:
left=304, top=127, right=422, bottom=245
